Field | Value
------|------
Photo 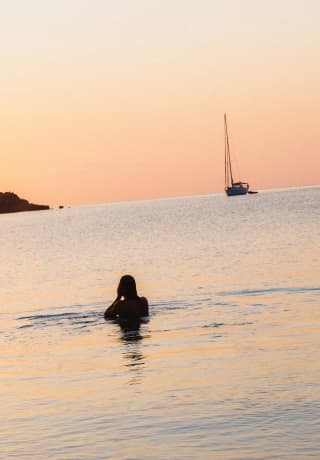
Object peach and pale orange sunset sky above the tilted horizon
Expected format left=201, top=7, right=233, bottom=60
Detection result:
left=0, top=0, right=320, bottom=206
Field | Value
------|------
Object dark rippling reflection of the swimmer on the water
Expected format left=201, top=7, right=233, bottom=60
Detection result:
left=117, top=318, right=149, bottom=385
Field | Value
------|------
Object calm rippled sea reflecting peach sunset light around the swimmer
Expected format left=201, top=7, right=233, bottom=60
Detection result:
left=0, top=188, right=320, bottom=460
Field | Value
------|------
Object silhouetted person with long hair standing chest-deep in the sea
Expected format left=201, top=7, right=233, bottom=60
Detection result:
left=104, top=275, right=149, bottom=320
